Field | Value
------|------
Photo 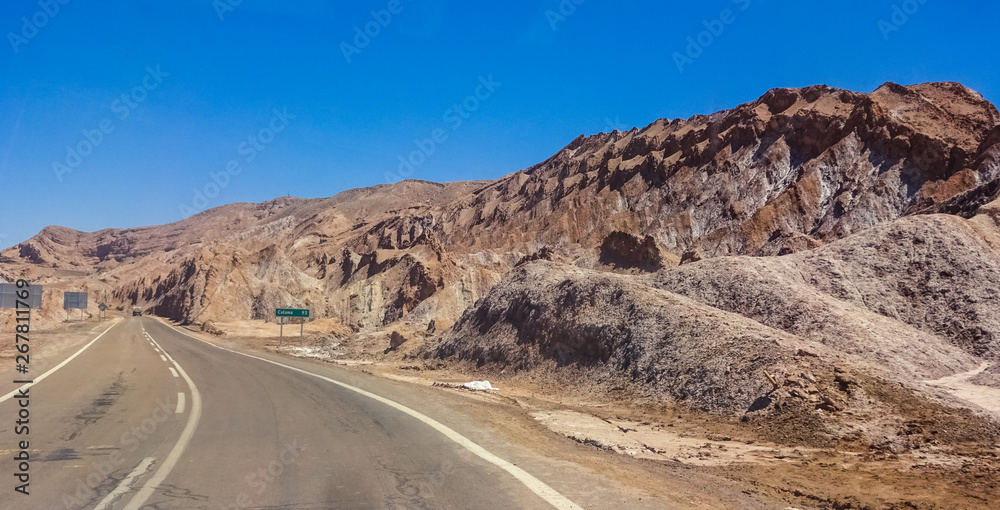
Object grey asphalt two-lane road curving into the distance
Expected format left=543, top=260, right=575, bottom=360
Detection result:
left=0, top=317, right=664, bottom=509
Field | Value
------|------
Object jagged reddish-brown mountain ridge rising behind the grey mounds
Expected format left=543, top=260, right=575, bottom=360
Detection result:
left=430, top=83, right=1000, bottom=261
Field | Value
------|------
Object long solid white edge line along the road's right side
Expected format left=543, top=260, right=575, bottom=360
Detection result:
left=164, top=322, right=583, bottom=510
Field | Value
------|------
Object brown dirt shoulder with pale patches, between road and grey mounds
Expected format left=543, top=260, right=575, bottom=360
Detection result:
left=365, top=362, right=1000, bottom=509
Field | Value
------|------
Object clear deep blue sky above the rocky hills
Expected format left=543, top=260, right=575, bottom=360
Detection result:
left=0, top=0, right=1000, bottom=246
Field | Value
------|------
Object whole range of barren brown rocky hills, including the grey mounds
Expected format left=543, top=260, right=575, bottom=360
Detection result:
left=0, top=83, right=1000, bottom=422
